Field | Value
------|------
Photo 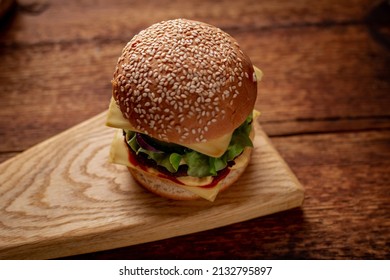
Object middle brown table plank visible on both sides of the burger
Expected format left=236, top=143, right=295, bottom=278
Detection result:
left=0, top=23, right=390, bottom=151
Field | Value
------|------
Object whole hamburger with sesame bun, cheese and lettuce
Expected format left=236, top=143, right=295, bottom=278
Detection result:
left=106, top=19, right=261, bottom=201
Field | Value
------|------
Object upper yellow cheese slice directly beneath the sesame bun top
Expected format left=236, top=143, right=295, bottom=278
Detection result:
left=106, top=97, right=232, bottom=157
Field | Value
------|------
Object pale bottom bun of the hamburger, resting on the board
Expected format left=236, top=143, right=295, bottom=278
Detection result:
left=128, top=148, right=252, bottom=200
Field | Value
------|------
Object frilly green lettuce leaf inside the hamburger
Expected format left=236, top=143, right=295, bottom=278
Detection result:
left=126, top=114, right=253, bottom=177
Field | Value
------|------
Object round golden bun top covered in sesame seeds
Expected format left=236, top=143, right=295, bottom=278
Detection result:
left=112, top=19, right=257, bottom=144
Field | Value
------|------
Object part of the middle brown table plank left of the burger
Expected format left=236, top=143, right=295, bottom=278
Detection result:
left=0, top=40, right=114, bottom=151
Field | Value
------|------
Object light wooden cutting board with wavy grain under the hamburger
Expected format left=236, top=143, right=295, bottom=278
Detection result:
left=0, top=112, right=304, bottom=259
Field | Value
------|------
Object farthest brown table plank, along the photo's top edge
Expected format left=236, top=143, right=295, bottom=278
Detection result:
left=0, top=0, right=375, bottom=44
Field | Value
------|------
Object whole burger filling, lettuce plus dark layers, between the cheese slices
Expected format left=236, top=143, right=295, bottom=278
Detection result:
left=123, top=114, right=253, bottom=177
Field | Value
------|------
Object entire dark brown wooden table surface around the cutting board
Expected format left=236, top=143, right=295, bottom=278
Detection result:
left=0, top=0, right=390, bottom=259
